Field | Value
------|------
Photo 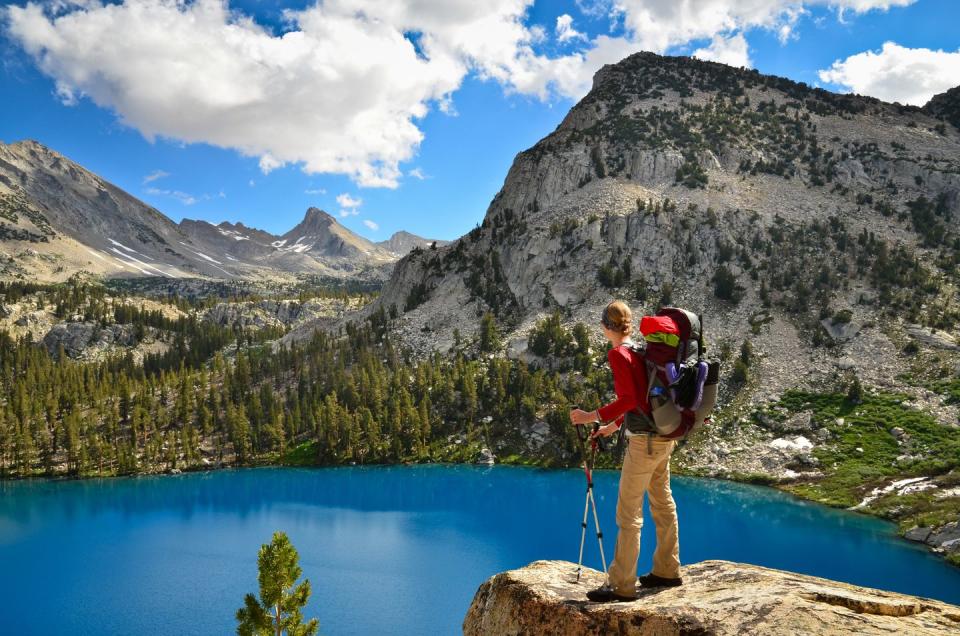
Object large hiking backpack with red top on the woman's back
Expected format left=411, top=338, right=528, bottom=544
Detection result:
left=624, top=307, right=720, bottom=439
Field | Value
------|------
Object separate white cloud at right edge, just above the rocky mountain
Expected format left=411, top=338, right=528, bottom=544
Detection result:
left=819, top=42, right=960, bottom=106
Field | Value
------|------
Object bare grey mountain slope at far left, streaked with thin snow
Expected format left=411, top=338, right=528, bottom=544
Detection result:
left=0, top=141, right=215, bottom=278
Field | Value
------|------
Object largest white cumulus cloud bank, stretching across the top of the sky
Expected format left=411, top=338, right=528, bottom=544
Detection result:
left=0, top=0, right=914, bottom=187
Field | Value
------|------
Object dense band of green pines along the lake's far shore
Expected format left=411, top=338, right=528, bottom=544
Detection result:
left=0, top=296, right=611, bottom=477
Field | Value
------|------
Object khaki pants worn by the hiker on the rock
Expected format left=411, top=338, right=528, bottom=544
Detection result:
left=610, top=435, right=680, bottom=596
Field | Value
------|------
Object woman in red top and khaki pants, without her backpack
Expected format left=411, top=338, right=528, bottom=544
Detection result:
left=570, top=300, right=682, bottom=602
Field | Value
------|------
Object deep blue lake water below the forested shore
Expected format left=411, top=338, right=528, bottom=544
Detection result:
left=0, top=466, right=960, bottom=635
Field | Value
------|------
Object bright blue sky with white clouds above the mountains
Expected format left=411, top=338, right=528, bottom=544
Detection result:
left=0, top=0, right=960, bottom=241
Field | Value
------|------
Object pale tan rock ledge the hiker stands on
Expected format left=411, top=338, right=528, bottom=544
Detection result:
left=463, top=561, right=960, bottom=636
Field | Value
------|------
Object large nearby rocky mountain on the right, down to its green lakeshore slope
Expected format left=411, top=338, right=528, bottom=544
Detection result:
left=360, top=53, right=960, bottom=512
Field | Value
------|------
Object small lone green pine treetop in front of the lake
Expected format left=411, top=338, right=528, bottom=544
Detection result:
left=236, top=532, right=320, bottom=636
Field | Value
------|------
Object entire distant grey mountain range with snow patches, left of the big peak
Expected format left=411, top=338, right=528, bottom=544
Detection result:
left=0, top=141, right=416, bottom=281
